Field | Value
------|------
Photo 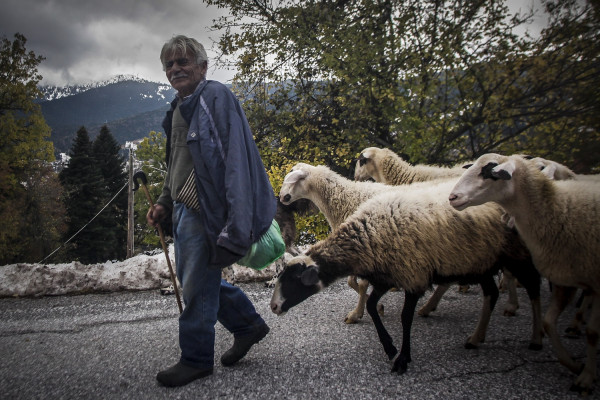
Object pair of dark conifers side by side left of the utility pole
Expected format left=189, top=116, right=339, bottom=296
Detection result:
left=59, top=126, right=127, bottom=263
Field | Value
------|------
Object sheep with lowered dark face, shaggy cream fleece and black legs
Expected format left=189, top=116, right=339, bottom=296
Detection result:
left=271, top=175, right=541, bottom=373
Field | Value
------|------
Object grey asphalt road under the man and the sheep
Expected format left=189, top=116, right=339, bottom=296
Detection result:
left=0, top=281, right=600, bottom=400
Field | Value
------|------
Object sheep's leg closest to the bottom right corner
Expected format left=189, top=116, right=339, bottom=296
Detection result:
left=571, top=294, right=600, bottom=395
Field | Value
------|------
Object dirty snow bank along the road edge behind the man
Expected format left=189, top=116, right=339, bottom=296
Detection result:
left=0, top=245, right=282, bottom=297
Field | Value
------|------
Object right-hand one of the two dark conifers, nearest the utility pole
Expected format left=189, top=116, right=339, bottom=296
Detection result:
left=92, top=125, right=128, bottom=260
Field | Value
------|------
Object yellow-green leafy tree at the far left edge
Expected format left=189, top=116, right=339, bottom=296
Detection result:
left=0, top=33, right=58, bottom=263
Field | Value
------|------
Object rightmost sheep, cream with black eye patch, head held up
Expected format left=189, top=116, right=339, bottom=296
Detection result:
left=449, top=154, right=600, bottom=393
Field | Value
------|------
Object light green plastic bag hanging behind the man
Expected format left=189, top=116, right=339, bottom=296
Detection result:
left=237, top=220, right=285, bottom=271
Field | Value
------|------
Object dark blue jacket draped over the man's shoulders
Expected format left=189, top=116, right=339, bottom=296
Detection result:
left=163, top=81, right=277, bottom=267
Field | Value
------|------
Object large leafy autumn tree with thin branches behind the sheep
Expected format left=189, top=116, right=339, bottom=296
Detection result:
left=208, top=0, right=600, bottom=174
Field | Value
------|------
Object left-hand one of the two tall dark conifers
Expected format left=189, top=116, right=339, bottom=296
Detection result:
left=59, top=127, right=107, bottom=263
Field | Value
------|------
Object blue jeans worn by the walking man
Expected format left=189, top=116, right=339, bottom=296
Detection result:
left=173, top=203, right=265, bottom=368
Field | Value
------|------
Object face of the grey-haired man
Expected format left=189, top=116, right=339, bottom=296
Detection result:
left=165, top=52, right=207, bottom=97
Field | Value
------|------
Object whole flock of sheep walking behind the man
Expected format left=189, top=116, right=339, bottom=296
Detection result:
left=271, top=147, right=600, bottom=394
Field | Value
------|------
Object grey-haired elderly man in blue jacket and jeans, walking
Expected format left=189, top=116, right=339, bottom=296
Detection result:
left=146, top=36, right=276, bottom=386
